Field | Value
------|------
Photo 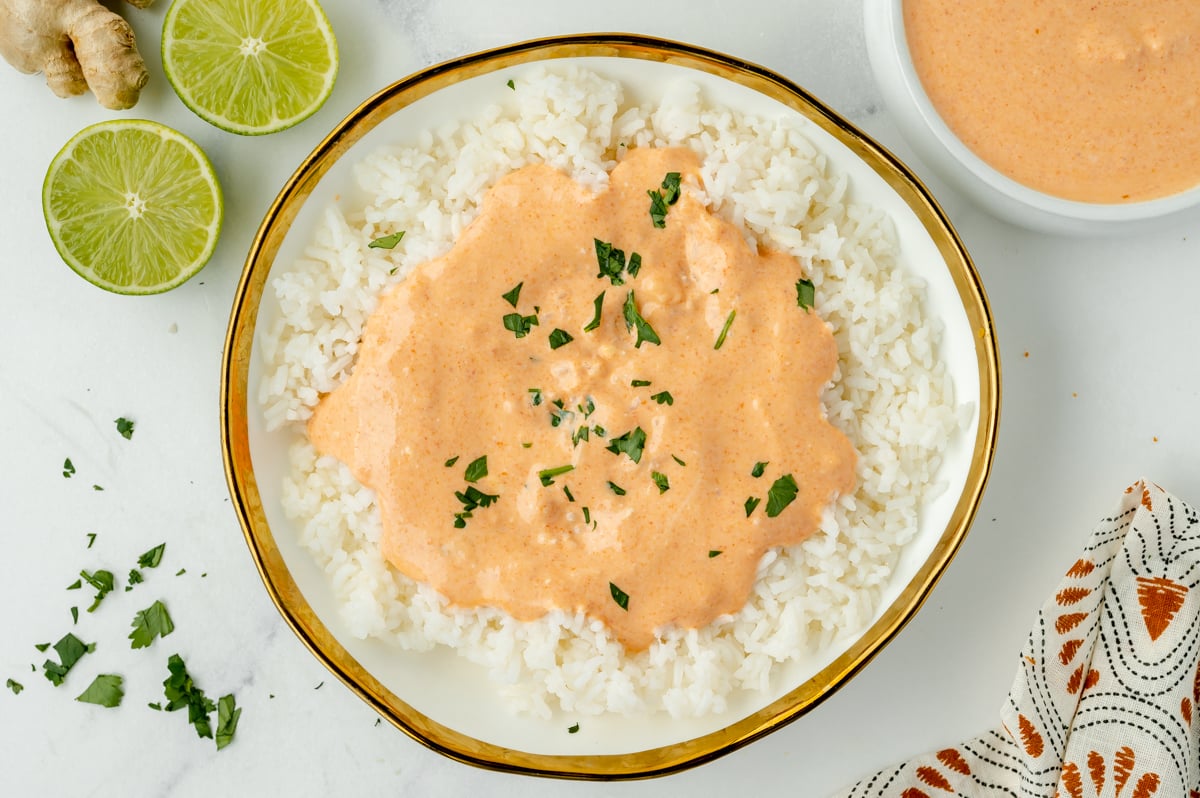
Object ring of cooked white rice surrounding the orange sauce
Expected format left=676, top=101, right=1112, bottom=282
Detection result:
left=259, top=67, right=958, bottom=716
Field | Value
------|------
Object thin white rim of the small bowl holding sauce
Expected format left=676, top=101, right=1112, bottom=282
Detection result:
left=864, top=0, right=1200, bottom=223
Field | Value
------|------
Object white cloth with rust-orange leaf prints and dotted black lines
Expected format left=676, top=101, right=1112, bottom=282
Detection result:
left=839, top=482, right=1200, bottom=798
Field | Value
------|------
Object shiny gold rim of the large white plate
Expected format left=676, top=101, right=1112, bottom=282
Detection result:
left=221, top=34, right=1000, bottom=779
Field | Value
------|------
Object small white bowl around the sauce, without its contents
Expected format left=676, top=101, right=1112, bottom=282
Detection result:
left=863, top=0, right=1200, bottom=234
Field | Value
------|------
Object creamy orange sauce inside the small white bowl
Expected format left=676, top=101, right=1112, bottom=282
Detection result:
left=904, top=0, right=1200, bottom=203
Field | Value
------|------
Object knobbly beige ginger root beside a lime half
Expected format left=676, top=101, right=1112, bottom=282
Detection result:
left=0, top=0, right=154, bottom=109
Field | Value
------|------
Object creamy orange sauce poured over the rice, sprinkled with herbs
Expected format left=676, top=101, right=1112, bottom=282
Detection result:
left=308, top=149, right=856, bottom=650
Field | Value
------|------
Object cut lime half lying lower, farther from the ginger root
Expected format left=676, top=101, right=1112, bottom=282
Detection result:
left=42, top=119, right=222, bottom=294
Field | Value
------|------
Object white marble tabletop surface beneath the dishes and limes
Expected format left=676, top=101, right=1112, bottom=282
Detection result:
left=0, top=0, right=1200, bottom=796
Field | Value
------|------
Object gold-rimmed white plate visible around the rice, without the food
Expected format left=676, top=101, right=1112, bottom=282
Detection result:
left=221, top=34, right=1000, bottom=779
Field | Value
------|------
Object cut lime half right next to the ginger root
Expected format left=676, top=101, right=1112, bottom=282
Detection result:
left=162, top=0, right=337, bottom=136
